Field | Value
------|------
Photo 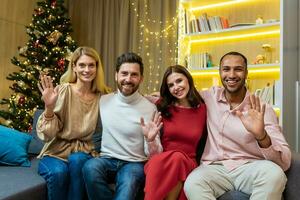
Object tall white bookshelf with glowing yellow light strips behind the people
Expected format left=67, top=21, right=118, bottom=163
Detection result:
left=178, top=0, right=284, bottom=119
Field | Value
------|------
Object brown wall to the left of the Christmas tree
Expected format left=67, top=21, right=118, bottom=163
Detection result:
left=0, top=0, right=37, bottom=109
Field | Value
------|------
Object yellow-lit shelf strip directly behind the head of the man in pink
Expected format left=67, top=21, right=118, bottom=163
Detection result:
left=189, top=63, right=280, bottom=80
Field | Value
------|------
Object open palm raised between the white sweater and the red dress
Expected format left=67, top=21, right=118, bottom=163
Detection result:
left=141, top=111, right=162, bottom=142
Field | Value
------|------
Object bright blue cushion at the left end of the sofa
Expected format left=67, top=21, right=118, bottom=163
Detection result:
left=0, top=126, right=32, bottom=167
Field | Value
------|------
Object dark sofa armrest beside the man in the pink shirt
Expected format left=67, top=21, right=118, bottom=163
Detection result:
left=284, top=152, right=300, bottom=199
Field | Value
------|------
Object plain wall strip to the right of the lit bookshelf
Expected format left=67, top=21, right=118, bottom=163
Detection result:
left=281, top=0, right=300, bottom=152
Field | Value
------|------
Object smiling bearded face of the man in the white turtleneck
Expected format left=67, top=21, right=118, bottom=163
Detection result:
left=115, top=63, right=143, bottom=96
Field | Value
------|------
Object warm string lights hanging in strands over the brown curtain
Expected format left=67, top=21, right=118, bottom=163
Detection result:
left=131, top=0, right=178, bottom=93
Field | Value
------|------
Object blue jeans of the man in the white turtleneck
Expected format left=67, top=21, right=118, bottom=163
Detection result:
left=82, top=157, right=145, bottom=200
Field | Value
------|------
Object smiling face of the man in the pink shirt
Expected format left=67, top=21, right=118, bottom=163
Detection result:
left=219, top=55, right=248, bottom=95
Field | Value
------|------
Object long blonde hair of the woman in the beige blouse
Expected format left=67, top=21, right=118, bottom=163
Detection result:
left=60, top=47, right=111, bottom=94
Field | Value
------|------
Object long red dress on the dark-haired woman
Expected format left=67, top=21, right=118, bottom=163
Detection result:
left=144, top=104, right=206, bottom=200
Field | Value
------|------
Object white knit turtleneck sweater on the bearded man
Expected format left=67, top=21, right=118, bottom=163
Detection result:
left=100, top=91, right=162, bottom=162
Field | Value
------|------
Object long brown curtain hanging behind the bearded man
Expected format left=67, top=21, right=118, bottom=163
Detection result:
left=68, top=0, right=178, bottom=93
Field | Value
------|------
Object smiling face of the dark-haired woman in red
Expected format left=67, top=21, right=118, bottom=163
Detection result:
left=167, top=72, right=190, bottom=102
